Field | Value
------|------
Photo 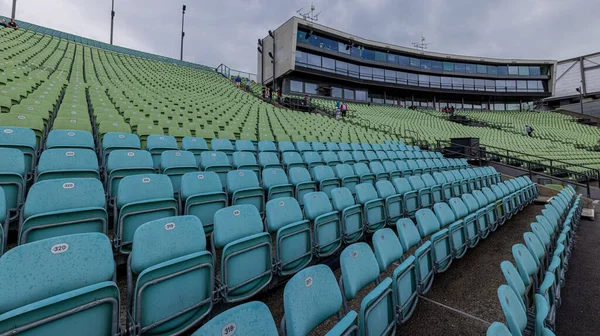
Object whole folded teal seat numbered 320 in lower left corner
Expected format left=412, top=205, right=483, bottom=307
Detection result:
left=0, top=233, right=120, bottom=335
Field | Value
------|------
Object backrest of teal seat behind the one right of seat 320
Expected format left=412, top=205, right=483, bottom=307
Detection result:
left=117, top=174, right=173, bottom=208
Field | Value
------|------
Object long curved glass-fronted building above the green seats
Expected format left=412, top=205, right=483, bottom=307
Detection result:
left=258, top=17, right=556, bottom=110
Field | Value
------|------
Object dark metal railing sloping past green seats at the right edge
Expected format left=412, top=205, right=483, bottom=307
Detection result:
left=436, top=140, right=600, bottom=198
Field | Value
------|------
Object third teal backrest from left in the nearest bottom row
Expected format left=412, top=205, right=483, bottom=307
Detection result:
left=340, top=242, right=379, bottom=300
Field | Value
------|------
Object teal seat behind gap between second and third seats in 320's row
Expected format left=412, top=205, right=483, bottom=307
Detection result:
left=179, top=172, right=229, bottom=234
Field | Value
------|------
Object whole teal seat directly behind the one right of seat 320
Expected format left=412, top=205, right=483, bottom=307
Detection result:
left=113, top=174, right=178, bottom=254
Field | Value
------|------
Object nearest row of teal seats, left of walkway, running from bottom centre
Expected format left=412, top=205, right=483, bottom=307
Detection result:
left=195, top=175, right=536, bottom=335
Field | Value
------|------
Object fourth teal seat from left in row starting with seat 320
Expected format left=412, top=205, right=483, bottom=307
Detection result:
left=266, top=197, right=312, bottom=276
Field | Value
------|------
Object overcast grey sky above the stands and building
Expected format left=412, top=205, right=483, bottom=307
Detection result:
left=0, top=0, right=600, bottom=73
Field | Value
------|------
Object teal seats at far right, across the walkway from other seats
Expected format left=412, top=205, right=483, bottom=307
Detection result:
left=488, top=186, right=583, bottom=335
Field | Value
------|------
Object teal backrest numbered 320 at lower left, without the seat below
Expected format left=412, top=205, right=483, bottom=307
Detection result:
left=0, top=234, right=115, bottom=313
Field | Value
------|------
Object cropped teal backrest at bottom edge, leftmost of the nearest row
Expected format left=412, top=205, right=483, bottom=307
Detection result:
left=192, top=301, right=278, bottom=336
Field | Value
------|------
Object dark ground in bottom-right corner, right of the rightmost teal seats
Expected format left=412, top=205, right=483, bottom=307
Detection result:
left=556, top=207, right=600, bottom=336
